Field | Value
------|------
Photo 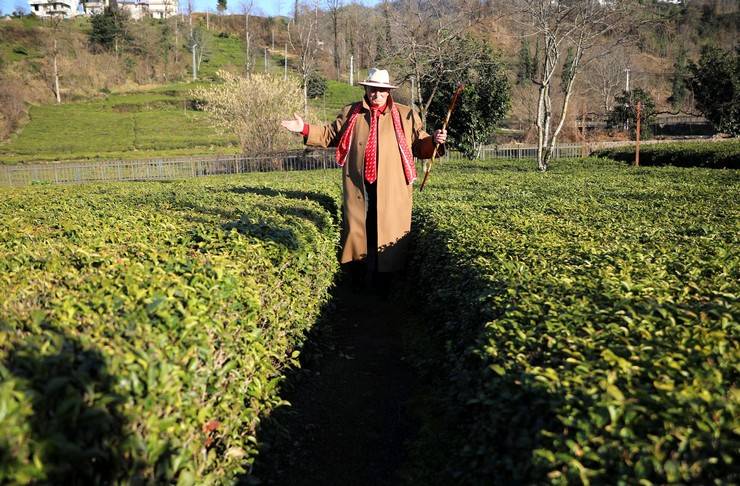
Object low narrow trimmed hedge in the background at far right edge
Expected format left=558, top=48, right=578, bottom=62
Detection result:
left=594, top=139, right=740, bottom=169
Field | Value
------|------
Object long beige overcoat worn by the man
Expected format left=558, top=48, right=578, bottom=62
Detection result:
left=306, top=97, right=441, bottom=272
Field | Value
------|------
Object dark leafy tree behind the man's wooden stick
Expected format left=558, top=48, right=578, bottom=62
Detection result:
left=422, top=37, right=511, bottom=159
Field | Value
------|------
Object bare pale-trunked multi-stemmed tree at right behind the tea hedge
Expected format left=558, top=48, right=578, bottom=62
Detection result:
left=512, top=0, right=640, bottom=171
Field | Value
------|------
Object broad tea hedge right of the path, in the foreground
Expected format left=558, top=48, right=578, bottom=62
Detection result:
left=410, top=159, right=740, bottom=484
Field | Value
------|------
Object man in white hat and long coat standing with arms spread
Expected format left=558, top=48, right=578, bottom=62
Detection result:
left=281, top=69, right=447, bottom=285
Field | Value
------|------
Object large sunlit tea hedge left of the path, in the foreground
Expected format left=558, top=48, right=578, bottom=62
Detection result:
left=0, top=174, right=338, bottom=484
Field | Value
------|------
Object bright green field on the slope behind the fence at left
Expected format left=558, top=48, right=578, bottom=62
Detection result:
left=0, top=85, right=238, bottom=162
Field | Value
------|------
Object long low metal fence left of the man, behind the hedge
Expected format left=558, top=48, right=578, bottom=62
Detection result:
left=0, top=150, right=336, bottom=186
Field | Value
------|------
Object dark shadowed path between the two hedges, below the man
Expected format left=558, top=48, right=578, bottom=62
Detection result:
left=250, top=284, right=417, bottom=485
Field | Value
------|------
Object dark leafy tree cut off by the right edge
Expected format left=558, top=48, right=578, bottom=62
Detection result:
left=690, top=46, right=740, bottom=136
